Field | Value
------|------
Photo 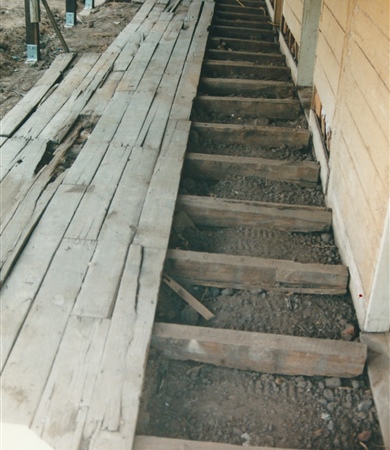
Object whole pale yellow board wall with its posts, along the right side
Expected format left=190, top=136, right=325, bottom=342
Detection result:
left=280, top=0, right=390, bottom=331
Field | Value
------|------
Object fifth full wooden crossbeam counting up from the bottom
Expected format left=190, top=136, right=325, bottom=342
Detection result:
left=192, top=122, right=310, bottom=149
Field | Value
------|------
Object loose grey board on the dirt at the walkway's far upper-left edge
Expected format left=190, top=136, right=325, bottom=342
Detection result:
left=0, top=53, right=75, bottom=136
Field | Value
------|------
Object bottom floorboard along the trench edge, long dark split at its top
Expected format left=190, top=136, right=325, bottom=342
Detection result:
left=83, top=245, right=166, bottom=450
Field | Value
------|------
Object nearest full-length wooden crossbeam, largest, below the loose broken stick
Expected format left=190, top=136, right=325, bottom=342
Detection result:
left=152, top=323, right=367, bottom=378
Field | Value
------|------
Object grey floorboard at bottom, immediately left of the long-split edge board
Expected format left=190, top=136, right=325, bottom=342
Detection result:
left=31, top=316, right=112, bottom=450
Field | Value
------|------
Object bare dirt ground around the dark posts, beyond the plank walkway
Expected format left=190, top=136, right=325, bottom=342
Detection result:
left=0, top=0, right=141, bottom=117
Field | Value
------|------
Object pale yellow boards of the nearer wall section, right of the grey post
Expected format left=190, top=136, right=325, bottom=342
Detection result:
left=314, top=0, right=389, bottom=312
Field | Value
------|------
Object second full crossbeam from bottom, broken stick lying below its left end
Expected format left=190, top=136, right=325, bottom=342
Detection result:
left=165, top=250, right=348, bottom=295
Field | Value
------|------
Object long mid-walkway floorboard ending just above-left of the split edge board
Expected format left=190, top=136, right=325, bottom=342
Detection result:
left=74, top=147, right=152, bottom=318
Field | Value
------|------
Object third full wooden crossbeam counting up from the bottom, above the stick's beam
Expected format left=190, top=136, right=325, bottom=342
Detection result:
left=176, top=195, right=332, bottom=233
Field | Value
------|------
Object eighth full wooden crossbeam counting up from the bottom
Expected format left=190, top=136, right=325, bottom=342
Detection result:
left=203, top=60, right=291, bottom=81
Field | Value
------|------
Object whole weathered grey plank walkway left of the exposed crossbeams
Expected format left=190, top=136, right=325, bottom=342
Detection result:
left=1, top=0, right=214, bottom=450
